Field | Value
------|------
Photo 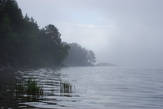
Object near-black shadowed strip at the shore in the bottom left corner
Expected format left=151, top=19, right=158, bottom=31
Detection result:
left=0, top=69, right=17, bottom=109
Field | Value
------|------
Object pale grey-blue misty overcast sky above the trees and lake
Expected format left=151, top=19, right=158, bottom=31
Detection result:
left=17, top=0, right=163, bottom=67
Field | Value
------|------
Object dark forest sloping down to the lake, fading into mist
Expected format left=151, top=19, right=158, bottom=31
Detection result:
left=0, top=0, right=95, bottom=67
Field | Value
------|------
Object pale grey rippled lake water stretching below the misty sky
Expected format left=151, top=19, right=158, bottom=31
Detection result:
left=14, top=67, right=163, bottom=109
